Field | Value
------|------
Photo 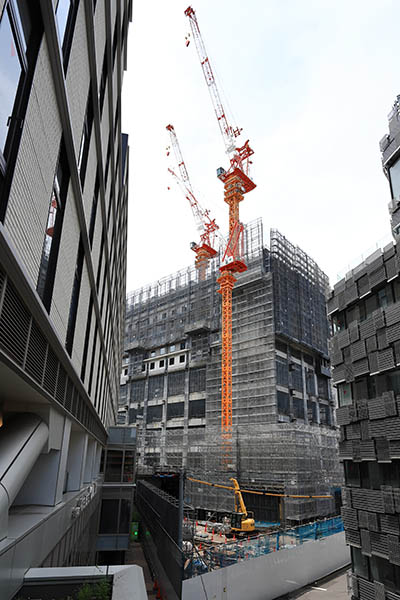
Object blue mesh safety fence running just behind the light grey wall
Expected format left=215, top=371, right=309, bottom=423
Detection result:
left=184, top=517, right=344, bottom=579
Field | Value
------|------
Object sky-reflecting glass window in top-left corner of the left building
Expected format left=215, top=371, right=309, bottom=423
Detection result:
left=0, top=4, right=23, bottom=154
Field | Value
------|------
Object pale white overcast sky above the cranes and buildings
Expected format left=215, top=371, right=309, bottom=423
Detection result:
left=122, top=0, right=400, bottom=291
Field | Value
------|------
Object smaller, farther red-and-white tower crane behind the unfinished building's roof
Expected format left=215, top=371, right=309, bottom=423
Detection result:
left=167, top=125, right=218, bottom=281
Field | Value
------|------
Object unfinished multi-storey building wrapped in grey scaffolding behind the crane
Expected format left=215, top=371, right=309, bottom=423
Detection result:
left=120, top=220, right=341, bottom=524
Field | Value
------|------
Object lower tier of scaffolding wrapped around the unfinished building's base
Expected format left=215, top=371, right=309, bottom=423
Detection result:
left=138, top=423, right=342, bottom=522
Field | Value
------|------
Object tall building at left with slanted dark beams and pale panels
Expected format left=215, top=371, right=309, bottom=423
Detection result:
left=0, top=0, right=131, bottom=599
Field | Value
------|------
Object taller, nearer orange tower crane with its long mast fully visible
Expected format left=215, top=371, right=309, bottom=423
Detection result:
left=185, top=6, right=256, bottom=437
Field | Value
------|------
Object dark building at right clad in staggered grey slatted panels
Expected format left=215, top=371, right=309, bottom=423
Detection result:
left=328, top=98, right=400, bottom=600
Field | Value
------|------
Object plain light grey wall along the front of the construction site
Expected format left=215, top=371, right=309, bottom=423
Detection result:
left=182, top=532, right=350, bottom=600
